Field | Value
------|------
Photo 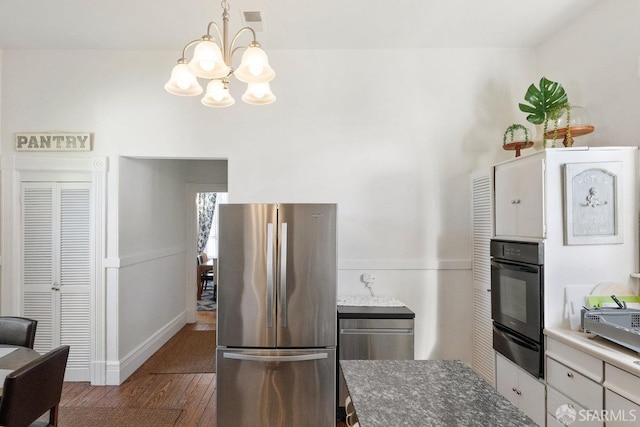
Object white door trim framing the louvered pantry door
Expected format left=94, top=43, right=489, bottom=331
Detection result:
left=0, top=153, right=108, bottom=385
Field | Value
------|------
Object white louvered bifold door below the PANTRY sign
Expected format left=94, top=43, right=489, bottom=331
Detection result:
left=22, top=182, right=91, bottom=381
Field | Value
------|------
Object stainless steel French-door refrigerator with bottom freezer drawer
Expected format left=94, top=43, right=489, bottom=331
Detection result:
left=216, top=204, right=337, bottom=427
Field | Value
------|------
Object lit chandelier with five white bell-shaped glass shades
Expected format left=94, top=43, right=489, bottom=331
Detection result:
left=164, top=0, right=276, bottom=107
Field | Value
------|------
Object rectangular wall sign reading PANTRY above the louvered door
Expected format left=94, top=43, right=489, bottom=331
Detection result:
left=16, top=132, right=91, bottom=151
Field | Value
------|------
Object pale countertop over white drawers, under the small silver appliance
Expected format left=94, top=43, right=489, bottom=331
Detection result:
left=544, top=328, right=640, bottom=376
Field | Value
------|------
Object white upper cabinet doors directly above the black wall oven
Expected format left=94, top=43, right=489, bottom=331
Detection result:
left=494, top=156, right=546, bottom=239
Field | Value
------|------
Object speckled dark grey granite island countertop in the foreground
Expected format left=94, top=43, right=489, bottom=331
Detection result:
left=340, top=360, right=536, bottom=427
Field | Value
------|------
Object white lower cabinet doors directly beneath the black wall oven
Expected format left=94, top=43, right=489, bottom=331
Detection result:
left=496, top=353, right=545, bottom=426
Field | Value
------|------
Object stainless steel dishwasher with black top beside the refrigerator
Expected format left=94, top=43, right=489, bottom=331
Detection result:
left=336, top=305, right=415, bottom=419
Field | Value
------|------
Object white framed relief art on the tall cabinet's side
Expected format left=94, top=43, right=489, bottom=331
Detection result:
left=564, top=162, right=622, bottom=245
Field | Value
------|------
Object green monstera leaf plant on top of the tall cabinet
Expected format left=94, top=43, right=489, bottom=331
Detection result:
left=518, top=77, right=571, bottom=146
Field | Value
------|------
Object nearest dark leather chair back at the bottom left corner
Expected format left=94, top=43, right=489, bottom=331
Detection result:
left=0, top=345, right=69, bottom=427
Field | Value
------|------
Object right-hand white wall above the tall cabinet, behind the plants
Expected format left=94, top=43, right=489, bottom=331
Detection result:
left=537, top=0, right=640, bottom=146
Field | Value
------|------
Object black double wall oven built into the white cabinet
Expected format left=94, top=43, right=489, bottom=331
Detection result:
left=490, top=239, right=544, bottom=378
